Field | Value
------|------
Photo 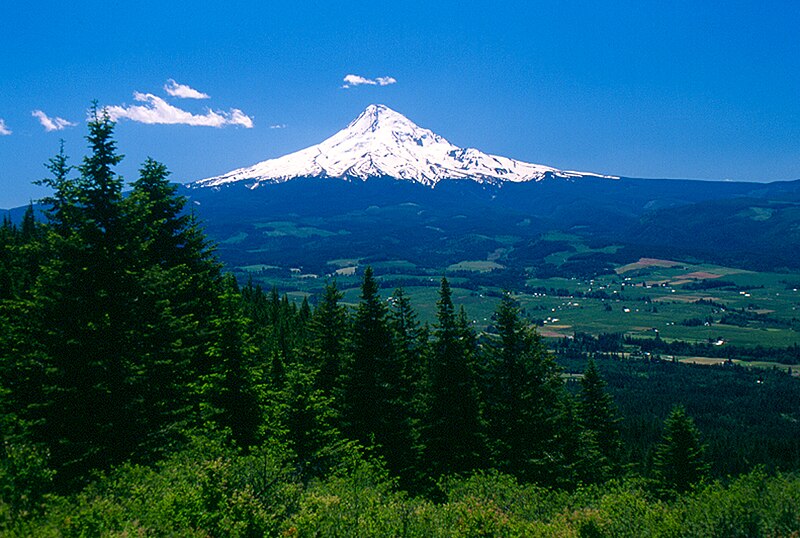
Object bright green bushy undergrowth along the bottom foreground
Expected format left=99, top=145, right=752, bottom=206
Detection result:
left=0, top=436, right=800, bottom=538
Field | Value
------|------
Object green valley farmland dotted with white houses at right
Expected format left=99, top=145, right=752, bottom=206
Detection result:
left=520, top=264, right=800, bottom=346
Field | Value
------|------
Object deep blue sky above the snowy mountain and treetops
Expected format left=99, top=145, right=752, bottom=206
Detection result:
left=0, top=0, right=800, bottom=207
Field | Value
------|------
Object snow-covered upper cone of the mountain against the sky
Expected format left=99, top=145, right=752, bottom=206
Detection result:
left=195, top=105, right=616, bottom=187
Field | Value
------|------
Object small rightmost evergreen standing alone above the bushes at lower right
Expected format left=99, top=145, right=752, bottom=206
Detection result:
left=653, top=405, right=708, bottom=493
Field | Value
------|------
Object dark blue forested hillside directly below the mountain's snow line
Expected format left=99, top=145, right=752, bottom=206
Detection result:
left=183, top=178, right=800, bottom=269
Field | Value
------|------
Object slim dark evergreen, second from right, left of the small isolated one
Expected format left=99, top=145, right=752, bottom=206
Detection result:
left=578, top=359, right=622, bottom=481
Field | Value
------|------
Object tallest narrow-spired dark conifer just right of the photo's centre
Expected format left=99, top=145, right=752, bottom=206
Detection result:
left=423, top=278, right=484, bottom=477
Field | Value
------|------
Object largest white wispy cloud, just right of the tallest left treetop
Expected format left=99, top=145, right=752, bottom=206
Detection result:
left=106, top=92, right=253, bottom=129
